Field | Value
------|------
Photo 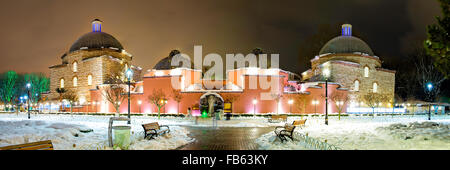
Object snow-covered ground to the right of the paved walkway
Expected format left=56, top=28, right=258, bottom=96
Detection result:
left=257, top=115, right=450, bottom=150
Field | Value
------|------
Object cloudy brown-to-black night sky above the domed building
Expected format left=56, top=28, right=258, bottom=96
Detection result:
left=0, top=0, right=440, bottom=74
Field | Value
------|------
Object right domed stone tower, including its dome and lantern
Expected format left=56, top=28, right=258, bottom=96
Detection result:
left=302, top=24, right=395, bottom=111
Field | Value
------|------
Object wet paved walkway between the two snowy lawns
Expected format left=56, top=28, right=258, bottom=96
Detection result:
left=178, top=127, right=274, bottom=150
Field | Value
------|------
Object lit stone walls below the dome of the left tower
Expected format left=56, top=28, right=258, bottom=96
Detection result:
left=49, top=49, right=141, bottom=102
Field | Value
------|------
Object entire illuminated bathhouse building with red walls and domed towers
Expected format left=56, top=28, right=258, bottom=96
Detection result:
left=45, top=20, right=395, bottom=114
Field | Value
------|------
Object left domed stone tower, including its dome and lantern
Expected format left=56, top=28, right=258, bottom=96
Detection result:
left=49, top=19, right=141, bottom=104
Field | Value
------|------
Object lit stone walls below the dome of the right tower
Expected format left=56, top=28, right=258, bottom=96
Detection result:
left=303, top=54, right=395, bottom=105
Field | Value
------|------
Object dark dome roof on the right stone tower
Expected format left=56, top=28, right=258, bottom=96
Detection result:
left=319, top=36, right=374, bottom=56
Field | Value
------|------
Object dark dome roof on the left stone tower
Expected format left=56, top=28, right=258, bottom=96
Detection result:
left=69, top=32, right=123, bottom=52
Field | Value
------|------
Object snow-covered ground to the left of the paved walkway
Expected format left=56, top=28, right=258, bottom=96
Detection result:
left=0, top=113, right=194, bottom=150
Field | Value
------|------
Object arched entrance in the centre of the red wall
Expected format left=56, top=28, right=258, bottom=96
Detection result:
left=200, top=92, right=223, bottom=117
